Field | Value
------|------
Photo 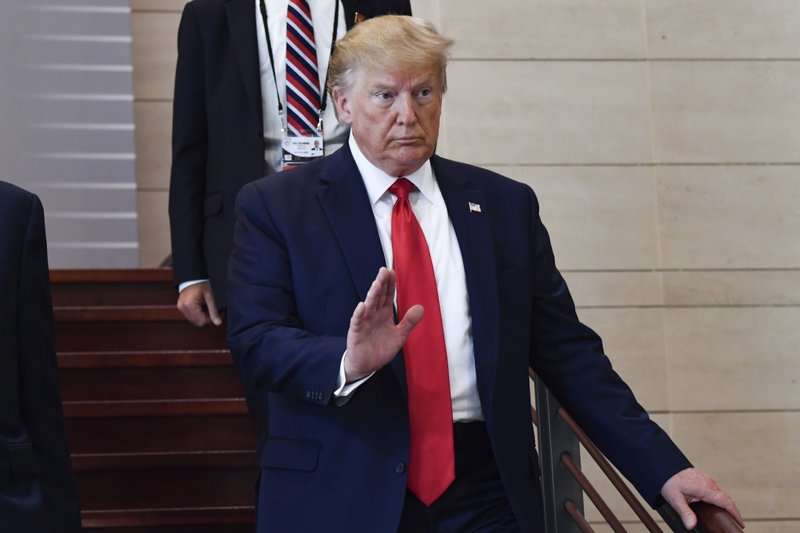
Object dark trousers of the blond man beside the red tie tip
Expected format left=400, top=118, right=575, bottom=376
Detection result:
left=398, top=422, right=520, bottom=533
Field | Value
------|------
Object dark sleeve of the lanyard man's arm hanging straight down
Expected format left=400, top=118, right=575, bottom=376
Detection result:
left=169, top=2, right=208, bottom=284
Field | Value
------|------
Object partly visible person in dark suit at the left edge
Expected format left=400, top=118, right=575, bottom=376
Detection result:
left=0, top=182, right=81, bottom=533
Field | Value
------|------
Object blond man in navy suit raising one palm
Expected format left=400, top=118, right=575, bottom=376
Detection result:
left=229, top=17, right=741, bottom=532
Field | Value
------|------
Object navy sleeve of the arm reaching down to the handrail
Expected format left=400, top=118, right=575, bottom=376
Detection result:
left=530, top=187, right=691, bottom=507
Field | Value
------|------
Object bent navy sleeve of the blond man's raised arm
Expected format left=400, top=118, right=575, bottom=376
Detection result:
left=228, top=183, right=346, bottom=405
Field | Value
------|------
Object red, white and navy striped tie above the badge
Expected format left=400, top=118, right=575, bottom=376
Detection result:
left=286, top=0, right=320, bottom=137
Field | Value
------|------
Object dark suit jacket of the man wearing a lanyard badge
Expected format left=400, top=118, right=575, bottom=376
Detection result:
left=169, top=0, right=411, bottom=308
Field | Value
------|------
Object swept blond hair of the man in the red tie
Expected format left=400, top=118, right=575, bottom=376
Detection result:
left=328, top=15, right=453, bottom=94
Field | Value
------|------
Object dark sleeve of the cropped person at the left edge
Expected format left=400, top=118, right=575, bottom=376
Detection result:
left=18, top=196, right=81, bottom=532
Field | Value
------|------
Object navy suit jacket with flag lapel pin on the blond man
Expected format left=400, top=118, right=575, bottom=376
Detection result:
left=229, top=145, right=689, bottom=532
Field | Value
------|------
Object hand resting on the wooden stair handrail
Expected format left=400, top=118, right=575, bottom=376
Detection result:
left=661, top=468, right=744, bottom=531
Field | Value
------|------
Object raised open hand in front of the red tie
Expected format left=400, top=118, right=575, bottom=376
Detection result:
left=344, top=267, right=423, bottom=383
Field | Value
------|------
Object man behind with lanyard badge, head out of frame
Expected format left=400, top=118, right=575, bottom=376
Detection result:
left=169, top=0, right=411, bottom=326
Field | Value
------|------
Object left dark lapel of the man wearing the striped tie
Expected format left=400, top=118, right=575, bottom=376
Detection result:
left=225, top=0, right=261, bottom=109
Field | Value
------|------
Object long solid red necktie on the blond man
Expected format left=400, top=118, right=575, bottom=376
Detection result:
left=389, top=178, right=455, bottom=505
